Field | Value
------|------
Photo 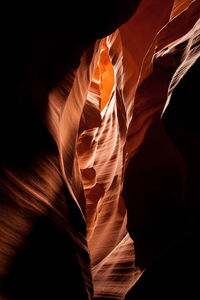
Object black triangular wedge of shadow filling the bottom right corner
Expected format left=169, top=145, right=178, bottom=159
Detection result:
left=125, top=231, right=200, bottom=300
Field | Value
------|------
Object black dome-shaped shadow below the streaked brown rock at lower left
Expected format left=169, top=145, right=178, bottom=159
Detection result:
left=2, top=218, right=88, bottom=300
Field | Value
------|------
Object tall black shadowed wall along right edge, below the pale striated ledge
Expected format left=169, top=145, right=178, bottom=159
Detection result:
left=125, top=59, right=200, bottom=300
